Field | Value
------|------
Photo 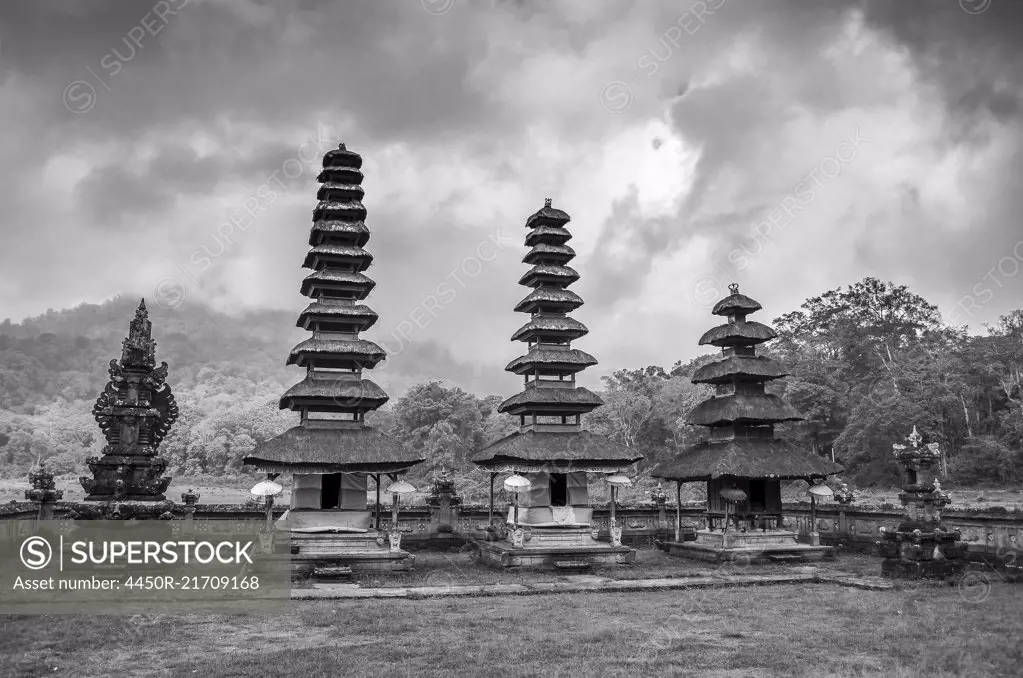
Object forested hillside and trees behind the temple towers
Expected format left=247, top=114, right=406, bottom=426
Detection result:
left=0, top=278, right=1023, bottom=485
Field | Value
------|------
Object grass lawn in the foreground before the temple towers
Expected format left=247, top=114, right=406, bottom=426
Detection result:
left=0, top=560, right=1023, bottom=678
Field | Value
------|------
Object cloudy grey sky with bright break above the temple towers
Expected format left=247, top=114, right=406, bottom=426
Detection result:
left=0, top=0, right=1023, bottom=393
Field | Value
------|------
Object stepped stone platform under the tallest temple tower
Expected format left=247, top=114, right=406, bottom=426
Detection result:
left=291, top=531, right=415, bottom=576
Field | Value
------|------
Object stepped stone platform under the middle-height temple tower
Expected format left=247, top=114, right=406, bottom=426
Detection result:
left=475, top=528, right=636, bottom=569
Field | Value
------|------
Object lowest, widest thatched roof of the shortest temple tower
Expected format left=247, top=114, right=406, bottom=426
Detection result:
left=651, top=438, right=843, bottom=482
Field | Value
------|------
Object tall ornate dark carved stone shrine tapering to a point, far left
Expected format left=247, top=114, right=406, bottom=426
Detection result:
left=79, top=300, right=178, bottom=502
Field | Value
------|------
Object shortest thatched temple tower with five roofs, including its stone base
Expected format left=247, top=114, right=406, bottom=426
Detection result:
left=651, top=283, right=842, bottom=561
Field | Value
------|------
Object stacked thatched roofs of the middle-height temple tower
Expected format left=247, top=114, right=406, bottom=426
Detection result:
left=472, top=198, right=642, bottom=470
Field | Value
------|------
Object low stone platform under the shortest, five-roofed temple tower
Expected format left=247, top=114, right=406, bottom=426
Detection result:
left=662, top=530, right=835, bottom=563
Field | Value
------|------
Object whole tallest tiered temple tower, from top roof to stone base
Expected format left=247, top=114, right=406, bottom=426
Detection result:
left=243, top=144, right=422, bottom=570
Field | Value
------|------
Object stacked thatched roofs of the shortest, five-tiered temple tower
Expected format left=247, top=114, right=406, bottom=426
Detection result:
left=652, top=283, right=842, bottom=482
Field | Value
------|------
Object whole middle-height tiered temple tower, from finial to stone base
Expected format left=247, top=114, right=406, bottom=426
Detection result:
left=471, top=198, right=642, bottom=567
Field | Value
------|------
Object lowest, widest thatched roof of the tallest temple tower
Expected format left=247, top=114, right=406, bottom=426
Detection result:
left=241, top=426, right=424, bottom=473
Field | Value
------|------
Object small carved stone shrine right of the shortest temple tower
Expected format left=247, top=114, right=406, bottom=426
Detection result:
left=877, top=426, right=967, bottom=579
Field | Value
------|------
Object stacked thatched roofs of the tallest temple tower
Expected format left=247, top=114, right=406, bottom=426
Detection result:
left=243, top=144, right=422, bottom=472
